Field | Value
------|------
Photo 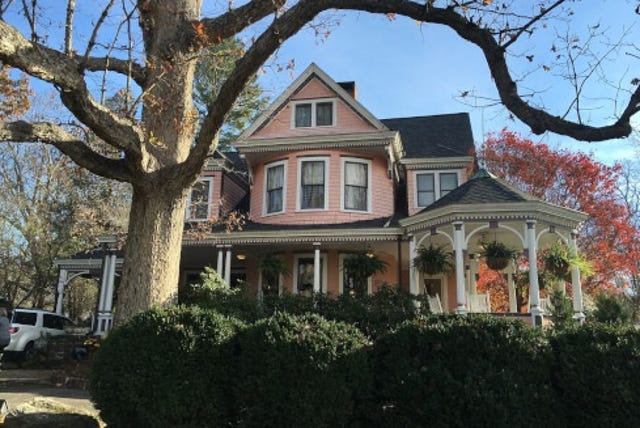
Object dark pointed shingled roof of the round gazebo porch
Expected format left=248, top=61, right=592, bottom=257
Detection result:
left=420, top=169, right=540, bottom=213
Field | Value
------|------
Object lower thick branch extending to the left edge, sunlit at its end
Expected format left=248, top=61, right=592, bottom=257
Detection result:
left=0, top=121, right=132, bottom=182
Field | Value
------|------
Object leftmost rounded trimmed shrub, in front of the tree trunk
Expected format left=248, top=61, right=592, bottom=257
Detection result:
left=90, top=307, right=241, bottom=427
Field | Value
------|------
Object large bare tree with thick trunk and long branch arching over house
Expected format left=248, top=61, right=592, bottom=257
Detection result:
left=0, top=0, right=640, bottom=321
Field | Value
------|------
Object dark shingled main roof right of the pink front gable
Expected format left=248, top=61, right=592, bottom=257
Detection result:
left=381, top=113, right=474, bottom=158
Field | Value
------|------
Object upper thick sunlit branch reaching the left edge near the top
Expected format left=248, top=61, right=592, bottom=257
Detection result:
left=0, top=21, right=144, bottom=155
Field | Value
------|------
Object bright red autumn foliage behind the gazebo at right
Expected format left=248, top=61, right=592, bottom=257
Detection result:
left=479, top=129, right=640, bottom=291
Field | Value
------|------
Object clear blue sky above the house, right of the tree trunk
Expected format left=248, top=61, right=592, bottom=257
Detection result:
left=252, top=5, right=640, bottom=164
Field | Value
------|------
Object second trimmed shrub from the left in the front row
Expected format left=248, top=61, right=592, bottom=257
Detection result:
left=233, top=313, right=370, bottom=427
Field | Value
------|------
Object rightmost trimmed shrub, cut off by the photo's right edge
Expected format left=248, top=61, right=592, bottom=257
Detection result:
left=550, top=325, right=640, bottom=427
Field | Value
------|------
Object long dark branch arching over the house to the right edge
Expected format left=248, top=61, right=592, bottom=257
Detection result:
left=192, top=0, right=640, bottom=147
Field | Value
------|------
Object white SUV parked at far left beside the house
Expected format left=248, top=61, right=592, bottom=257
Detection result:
left=4, top=308, right=73, bottom=358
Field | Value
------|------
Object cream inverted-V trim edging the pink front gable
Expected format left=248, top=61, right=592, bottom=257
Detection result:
left=238, top=63, right=388, bottom=142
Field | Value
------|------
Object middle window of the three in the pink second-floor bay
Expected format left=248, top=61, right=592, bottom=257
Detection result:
left=298, top=158, right=328, bottom=210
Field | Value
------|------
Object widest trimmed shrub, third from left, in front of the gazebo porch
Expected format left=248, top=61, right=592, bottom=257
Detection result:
left=369, top=316, right=563, bottom=428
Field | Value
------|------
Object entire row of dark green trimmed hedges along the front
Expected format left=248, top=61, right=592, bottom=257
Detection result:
left=91, top=310, right=640, bottom=428
